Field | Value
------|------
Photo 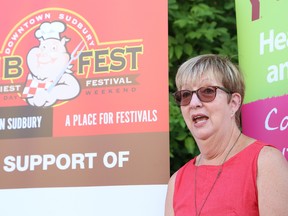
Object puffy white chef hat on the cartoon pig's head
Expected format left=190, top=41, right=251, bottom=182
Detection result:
left=35, top=21, right=66, bottom=40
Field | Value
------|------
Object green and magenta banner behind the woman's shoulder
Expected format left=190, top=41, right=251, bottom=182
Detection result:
left=236, top=0, right=288, bottom=159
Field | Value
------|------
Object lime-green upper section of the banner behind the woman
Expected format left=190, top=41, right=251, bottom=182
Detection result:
left=236, top=0, right=288, bottom=103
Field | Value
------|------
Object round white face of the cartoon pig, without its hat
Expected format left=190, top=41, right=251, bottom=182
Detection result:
left=27, top=39, right=69, bottom=81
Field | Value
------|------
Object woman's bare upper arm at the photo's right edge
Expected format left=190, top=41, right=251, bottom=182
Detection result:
left=257, top=146, right=288, bottom=216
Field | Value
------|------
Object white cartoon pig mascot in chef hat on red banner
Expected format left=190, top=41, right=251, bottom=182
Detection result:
left=23, top=21, right=80, bottom=107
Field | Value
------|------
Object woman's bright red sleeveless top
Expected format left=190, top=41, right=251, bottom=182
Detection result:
left=173, top=141, right=266, bottom=216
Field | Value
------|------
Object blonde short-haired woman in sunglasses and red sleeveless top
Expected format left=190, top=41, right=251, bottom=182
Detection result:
left=165, top=54, right=288, bottom=216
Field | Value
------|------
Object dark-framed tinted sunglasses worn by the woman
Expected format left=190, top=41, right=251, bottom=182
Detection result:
left=173, top=86, right=232, bottom=106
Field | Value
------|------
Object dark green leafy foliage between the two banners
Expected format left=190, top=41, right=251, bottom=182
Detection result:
left=168, top=0, right=238, bottom=174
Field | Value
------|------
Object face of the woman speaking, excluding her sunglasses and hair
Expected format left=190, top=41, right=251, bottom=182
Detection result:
left=181, top=73, right=233, bottom=140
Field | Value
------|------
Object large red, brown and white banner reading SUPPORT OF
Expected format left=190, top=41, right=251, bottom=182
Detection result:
left=0, top=0, right=169, bottom=216
